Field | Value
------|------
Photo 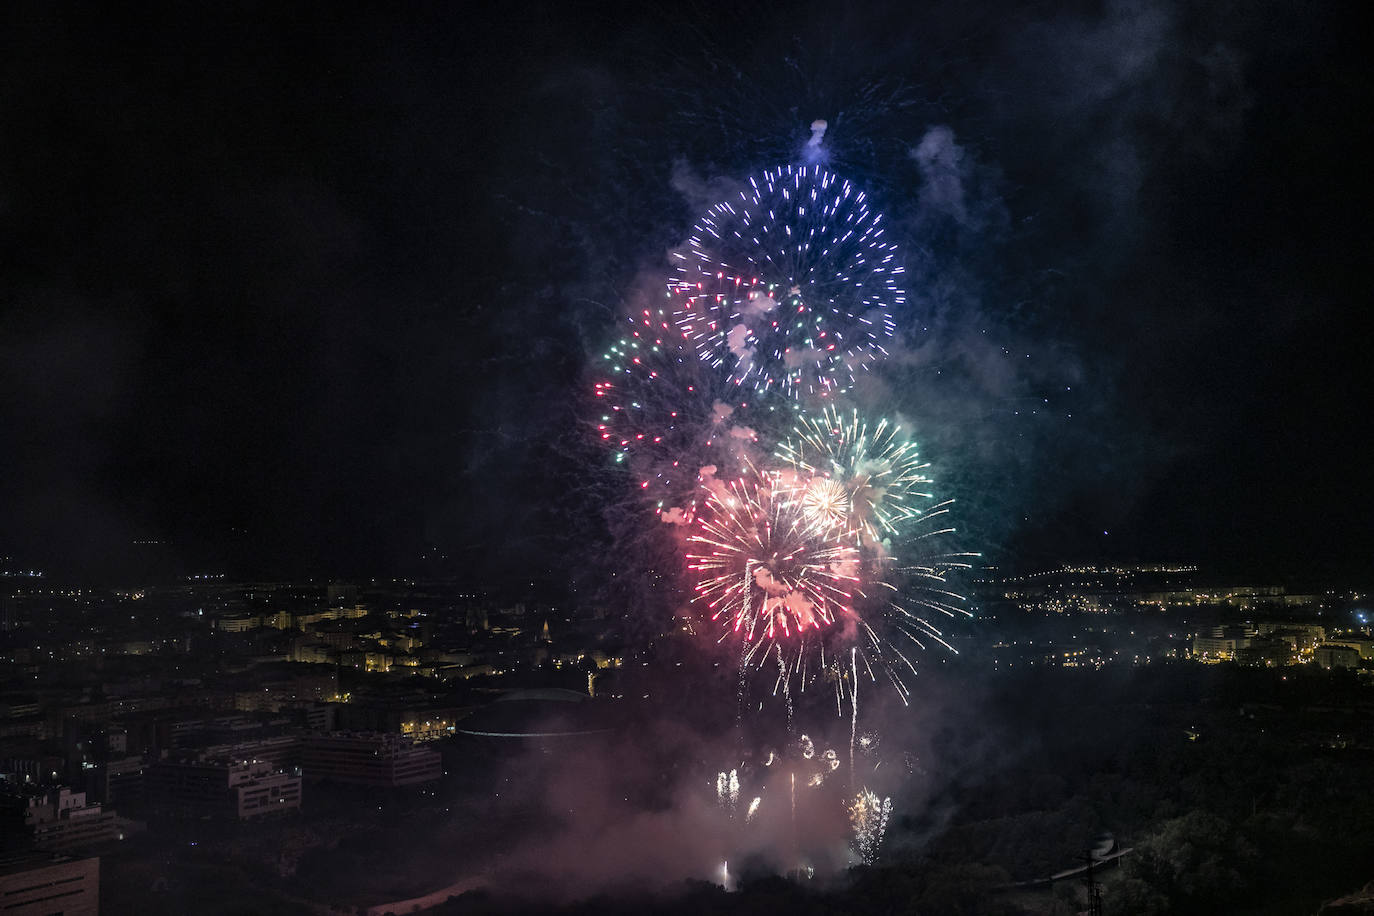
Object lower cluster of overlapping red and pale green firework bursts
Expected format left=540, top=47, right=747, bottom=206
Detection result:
left=687, top=409, right=970, bottom=714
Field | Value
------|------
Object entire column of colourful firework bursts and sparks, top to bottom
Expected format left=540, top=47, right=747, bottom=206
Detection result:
left=594, top=157, right=969, bottom=829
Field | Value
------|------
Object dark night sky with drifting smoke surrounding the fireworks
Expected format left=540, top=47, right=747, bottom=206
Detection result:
left=0, top=3, right=1374, bottom=587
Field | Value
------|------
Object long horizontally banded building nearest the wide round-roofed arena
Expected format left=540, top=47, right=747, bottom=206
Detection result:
left=301, top=732, right=444, bottom=787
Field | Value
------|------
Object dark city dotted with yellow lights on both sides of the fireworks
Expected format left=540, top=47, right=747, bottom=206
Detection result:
left=8, top=564, right=1374, bottom=915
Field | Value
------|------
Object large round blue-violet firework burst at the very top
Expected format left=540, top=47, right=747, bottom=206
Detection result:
left=669, top=165, right=905, bottom=397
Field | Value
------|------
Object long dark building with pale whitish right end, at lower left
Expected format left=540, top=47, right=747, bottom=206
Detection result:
left=147, top=757, right=301, bottom=820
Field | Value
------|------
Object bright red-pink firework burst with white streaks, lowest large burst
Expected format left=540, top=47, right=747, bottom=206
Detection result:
left=686, top=448, right=969, bottom=708
